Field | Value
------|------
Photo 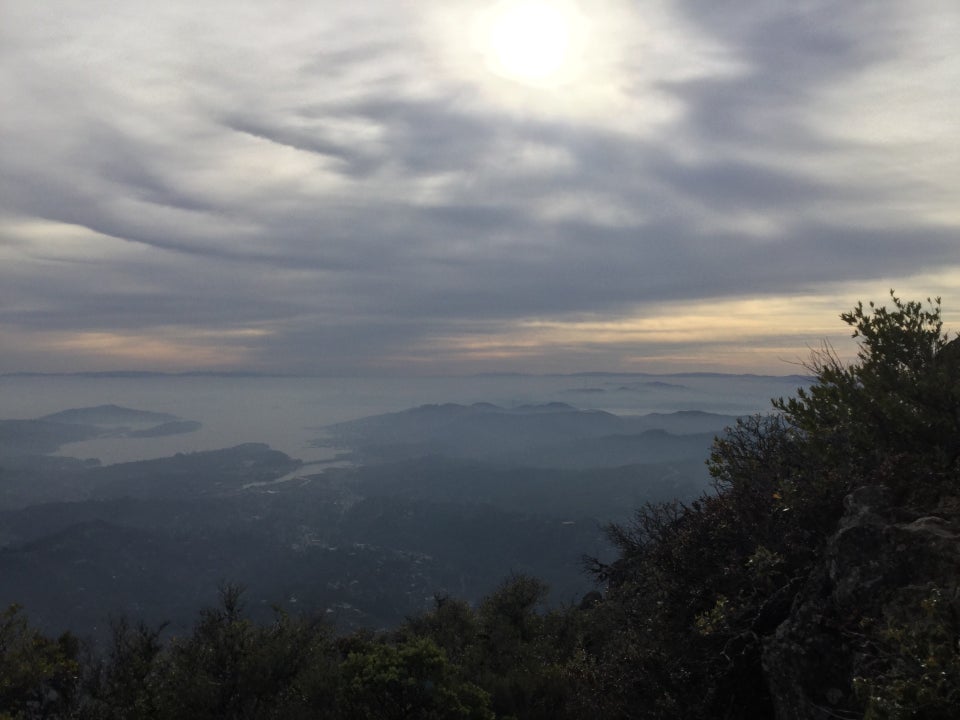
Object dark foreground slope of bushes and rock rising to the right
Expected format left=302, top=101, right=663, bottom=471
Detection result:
left=0, top=297, right=960, bottom=720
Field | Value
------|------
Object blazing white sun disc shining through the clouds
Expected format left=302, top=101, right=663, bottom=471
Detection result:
left=487, top=1, right=575, bottom=84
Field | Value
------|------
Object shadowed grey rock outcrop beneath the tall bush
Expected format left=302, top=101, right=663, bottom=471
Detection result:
left=762, top=486, right=960, bottom=720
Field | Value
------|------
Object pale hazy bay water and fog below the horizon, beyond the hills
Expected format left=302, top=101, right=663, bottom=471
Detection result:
left=0, top=374, right=804, bottom=464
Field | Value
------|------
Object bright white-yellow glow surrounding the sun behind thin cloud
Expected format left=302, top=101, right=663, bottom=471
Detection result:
left=425, top=0, right=742, bottom=133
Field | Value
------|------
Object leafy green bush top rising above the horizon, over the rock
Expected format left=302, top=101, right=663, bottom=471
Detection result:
left=774, top=291, right=960, bottom=496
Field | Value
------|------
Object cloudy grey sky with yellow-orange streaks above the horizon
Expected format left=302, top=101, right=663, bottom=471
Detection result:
left=0, top=0, right=960, bottom=375
